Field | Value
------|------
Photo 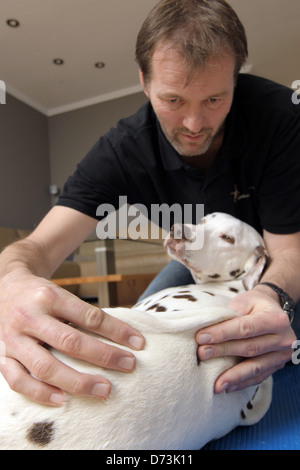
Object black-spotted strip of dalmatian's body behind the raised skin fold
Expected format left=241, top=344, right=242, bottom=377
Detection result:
left=133, top=281, right=244, bottom=312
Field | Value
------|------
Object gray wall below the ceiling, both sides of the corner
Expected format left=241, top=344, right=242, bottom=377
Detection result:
left=0, top=93, right=146, bottom=230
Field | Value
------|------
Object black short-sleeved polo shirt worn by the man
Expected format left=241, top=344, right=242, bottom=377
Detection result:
left=57, top=74, right=300, bottom=234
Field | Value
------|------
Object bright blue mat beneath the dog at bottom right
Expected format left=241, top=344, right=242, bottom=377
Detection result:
left=203, top=363, right=300, bottom=450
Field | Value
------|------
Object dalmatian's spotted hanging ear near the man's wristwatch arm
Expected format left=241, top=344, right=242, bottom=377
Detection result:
left=243, top=245, right=270, bottom=290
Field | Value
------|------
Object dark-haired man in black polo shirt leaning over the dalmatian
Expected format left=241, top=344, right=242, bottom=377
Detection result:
left=0, top=0, right=300, bottom=406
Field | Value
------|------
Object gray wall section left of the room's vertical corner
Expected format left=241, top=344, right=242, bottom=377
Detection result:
left=0, top=94, right=51, bottom=230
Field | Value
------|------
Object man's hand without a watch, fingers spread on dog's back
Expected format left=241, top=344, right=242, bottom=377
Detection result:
left=0, top=275, right=144, bottom=405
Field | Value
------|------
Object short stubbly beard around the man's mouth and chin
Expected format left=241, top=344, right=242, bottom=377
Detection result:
left=160, top=122, right=224, bottom=157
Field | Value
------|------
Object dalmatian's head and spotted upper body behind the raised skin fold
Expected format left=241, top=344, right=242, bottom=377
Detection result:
left=136, top=212, right=269, bottom=312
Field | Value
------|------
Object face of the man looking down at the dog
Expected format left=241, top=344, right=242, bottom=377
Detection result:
left=140, top=44, right=236, bottom=157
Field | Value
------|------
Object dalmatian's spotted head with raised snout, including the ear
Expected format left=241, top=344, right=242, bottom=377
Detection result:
left=164, top=212, right=269, bottom=290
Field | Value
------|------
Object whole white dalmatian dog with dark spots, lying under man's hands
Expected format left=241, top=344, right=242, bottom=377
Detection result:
left=0, top=213, right=272, bottom=450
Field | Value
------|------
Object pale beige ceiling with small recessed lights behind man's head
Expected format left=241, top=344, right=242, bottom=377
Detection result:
left=0, top=0, right=300, bottom=116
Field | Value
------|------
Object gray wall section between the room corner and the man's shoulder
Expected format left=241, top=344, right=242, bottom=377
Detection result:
left=49, top=93, right=146, bottom=197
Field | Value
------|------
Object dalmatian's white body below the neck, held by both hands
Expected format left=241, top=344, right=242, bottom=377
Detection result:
left=0, top=285, right=272, bottom=450
